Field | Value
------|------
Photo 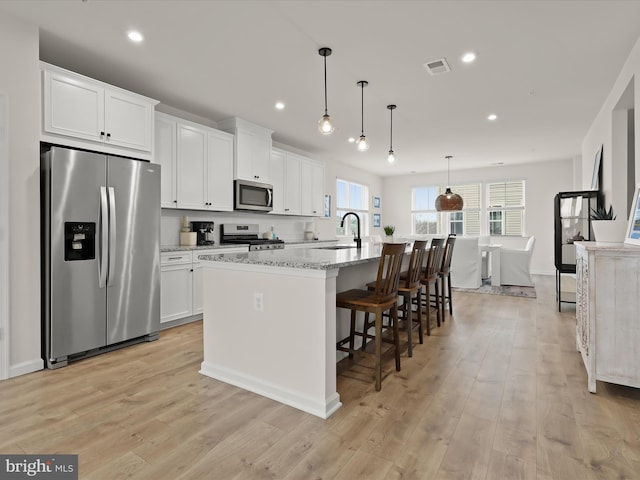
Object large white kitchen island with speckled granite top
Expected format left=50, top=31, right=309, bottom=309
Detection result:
left=199, top=243, right=404, bottom=418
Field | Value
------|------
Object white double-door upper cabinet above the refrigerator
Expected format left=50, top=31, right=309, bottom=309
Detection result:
left=41, top=62, right=158, bottom=160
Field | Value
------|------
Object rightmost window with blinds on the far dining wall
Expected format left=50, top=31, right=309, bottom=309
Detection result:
left=487, top=180, right=524, bottom=235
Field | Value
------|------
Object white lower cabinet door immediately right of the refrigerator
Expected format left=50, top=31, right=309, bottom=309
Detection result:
left=160, top=263, right=193, bottom=323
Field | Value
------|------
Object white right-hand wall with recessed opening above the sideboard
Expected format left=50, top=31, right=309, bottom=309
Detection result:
left=582, top=35, right=640, bottom=229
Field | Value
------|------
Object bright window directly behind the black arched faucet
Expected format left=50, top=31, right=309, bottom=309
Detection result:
left=336, top=179, right=369, bottom=237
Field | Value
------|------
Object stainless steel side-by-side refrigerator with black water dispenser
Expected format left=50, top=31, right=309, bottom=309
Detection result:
left=41, top=147, right=160, bottom=368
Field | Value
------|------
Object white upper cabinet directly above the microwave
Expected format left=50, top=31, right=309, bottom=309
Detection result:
left=218, top=117, right=273, bottom=183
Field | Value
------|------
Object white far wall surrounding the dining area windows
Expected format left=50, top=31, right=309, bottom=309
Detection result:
left=382, top=158, right=574, bottom=274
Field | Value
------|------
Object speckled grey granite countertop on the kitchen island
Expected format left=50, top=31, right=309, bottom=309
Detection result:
left=198, top=243, right=411, bottom=270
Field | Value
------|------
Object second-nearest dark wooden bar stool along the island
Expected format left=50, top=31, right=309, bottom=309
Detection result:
left=362, top=240, right=428, bottom=357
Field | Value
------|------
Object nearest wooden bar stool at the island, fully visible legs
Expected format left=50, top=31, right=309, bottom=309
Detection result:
left=336, top=243, right=406, bottom=391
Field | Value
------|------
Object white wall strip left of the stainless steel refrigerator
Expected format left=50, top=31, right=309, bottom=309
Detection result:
left=0, top=13, right=43, bottom=376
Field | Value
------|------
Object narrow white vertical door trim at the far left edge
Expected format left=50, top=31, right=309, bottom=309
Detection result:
left=0, top=94, right=11, bottom=380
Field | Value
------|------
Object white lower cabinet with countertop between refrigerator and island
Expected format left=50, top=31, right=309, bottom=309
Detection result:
left=160, top=247, right=248, bottom=326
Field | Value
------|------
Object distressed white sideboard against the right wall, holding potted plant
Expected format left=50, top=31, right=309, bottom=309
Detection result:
left=575, top=242, right=640, bottom=393
